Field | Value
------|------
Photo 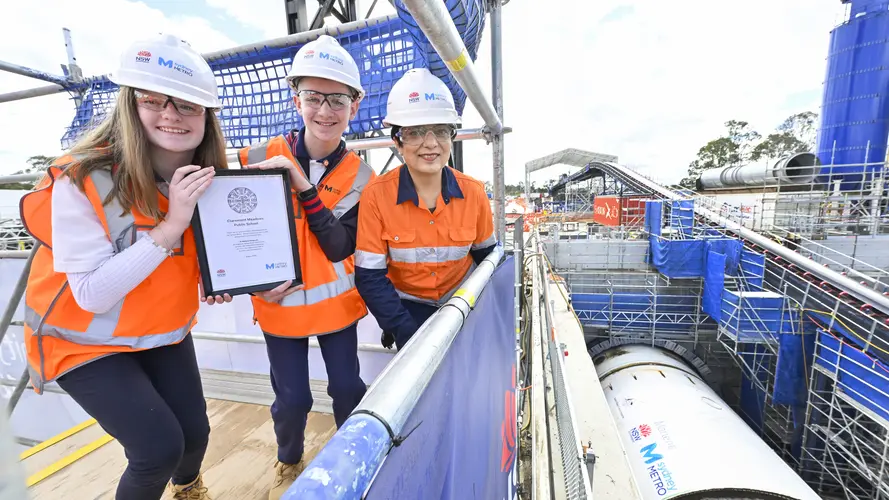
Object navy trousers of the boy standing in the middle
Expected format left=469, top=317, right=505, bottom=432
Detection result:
left=265, top=325, right=367, bottom=464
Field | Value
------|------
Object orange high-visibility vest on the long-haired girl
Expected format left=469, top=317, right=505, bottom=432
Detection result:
left=20, top=155, right=200, bottom=394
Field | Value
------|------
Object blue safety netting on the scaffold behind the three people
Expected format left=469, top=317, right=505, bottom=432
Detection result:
left=61, top=0, right=485, bottom=149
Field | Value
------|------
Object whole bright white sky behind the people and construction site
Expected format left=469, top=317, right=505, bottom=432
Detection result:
left=0, top=0, right=844, bottom=188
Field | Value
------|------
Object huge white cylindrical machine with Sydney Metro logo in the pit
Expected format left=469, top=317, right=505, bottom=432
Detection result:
left=593, top=345, right=820, bottom=500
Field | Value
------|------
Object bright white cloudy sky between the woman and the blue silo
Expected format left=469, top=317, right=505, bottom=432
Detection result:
left=454, top=0, right=837, bottom=184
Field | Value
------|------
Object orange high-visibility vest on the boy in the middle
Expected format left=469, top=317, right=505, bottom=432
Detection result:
left=238, top=136, right=376, bottom=337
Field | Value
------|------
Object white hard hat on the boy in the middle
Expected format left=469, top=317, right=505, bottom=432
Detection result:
left=287, top=35, right=364, bottom=99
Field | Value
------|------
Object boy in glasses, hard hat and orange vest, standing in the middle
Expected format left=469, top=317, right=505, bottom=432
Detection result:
left=238, top=35, right=376, bottom=500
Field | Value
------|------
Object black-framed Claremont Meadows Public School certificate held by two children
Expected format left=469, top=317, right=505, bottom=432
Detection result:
left=191, top=169, right=302, bottom=297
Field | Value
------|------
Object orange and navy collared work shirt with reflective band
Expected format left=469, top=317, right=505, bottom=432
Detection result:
left=355, top=165, right=496, bottom=338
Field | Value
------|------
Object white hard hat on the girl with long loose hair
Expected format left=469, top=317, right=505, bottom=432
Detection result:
left=109, top=34, right=222, bottom=108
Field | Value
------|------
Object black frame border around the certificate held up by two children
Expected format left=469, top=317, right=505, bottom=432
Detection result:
left=191, top=168, right=303, bottom=297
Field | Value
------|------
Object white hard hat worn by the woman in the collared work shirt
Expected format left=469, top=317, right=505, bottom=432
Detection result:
left=383, top=68, right=460, bottom=127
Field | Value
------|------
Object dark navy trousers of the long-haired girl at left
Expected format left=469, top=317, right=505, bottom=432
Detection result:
left=58, top=335, right=210, bottom=500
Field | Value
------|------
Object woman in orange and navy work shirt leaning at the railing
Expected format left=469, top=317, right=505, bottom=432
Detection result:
left=355, top=68, right=496, bottom=349
